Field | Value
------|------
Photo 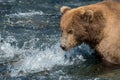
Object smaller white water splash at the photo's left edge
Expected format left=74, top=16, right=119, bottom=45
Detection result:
left=0, top=35, right=19, bottom=63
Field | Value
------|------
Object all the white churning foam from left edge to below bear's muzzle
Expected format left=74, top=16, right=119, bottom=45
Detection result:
left=0, top=36, right=84, bottom=76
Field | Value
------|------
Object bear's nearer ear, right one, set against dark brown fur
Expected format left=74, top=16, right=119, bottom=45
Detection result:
left=82, top=10, right=94, bottom=22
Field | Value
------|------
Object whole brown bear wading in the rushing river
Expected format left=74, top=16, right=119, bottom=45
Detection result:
left=60, top=0, right=120, bottom=64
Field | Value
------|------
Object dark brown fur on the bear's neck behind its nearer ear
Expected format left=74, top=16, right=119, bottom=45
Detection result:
left=86, top=17, right=105, bottom=48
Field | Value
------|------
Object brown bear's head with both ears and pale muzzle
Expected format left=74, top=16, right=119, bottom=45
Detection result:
left=60, top=6, right=102, bottom=50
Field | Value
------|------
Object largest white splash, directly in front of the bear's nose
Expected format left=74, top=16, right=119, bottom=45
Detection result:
left=11, top=44, right=71, bottom=76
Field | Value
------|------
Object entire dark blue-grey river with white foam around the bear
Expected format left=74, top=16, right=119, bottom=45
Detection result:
left=0, top=0, right=120, bottom=80
